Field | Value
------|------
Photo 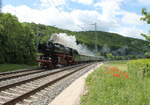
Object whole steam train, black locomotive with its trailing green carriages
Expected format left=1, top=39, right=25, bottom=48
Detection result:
left=37, top=41, right=102, bottom=69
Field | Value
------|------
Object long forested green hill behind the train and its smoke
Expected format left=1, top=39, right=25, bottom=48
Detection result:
left=23, top=23, right=150, bottom=56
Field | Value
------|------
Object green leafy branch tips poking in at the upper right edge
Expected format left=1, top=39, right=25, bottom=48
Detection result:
left=141, top=8, right=150, bottom=41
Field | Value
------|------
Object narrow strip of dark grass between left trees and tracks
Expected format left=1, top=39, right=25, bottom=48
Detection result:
left=0, top=64, right=37, bottom=72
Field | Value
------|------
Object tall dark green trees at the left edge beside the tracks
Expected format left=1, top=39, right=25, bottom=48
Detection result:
left=0, top=13, right=36, bottom=64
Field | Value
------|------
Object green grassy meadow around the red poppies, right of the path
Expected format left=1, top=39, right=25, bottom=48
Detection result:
left=80, top=62, right=150, bottom=105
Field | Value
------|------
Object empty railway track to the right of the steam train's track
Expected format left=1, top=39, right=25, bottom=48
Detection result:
left=0, top=64, right=94, bottom=105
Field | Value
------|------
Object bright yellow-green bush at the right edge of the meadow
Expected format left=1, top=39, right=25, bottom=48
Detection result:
left=127, top=59, right=150, bottom=77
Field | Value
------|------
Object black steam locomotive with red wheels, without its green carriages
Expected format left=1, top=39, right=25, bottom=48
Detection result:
left=38, top=41, right=74, bottom=68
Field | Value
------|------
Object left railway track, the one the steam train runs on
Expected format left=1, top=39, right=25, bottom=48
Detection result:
left=0, top=64, right=84, bottom=87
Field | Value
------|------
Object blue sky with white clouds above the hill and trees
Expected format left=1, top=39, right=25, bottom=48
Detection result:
left=3, top=0, right=150, bottom=38
